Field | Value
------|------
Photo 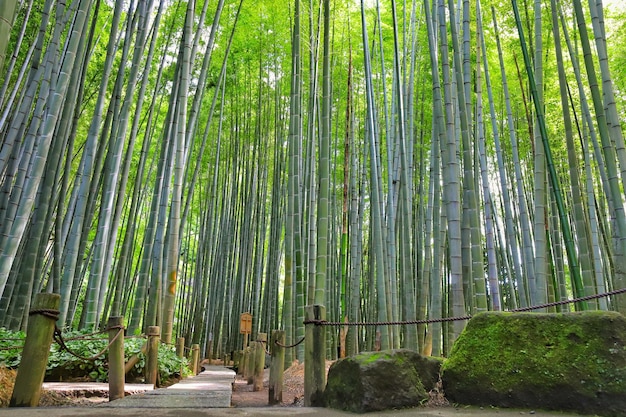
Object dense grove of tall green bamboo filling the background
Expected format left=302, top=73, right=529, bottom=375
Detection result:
left=0, top=0, right=626, bottom=364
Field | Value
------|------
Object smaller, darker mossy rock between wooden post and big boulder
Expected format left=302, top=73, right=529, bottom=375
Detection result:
left=324, top=349, right=441, bottom=413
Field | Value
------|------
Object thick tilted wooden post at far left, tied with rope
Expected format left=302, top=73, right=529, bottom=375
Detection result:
left=9, top=293, right=61, bottom=407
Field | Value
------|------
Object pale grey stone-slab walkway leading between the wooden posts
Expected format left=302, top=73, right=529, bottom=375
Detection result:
left=100, top=366, right=235, bottom=408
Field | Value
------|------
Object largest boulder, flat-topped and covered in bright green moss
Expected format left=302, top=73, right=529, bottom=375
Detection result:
left=442, top=311, right=626, bottom=416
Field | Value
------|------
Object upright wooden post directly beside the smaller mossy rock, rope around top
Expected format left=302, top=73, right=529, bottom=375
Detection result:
left=304, top=305, right=326, bottom=407
